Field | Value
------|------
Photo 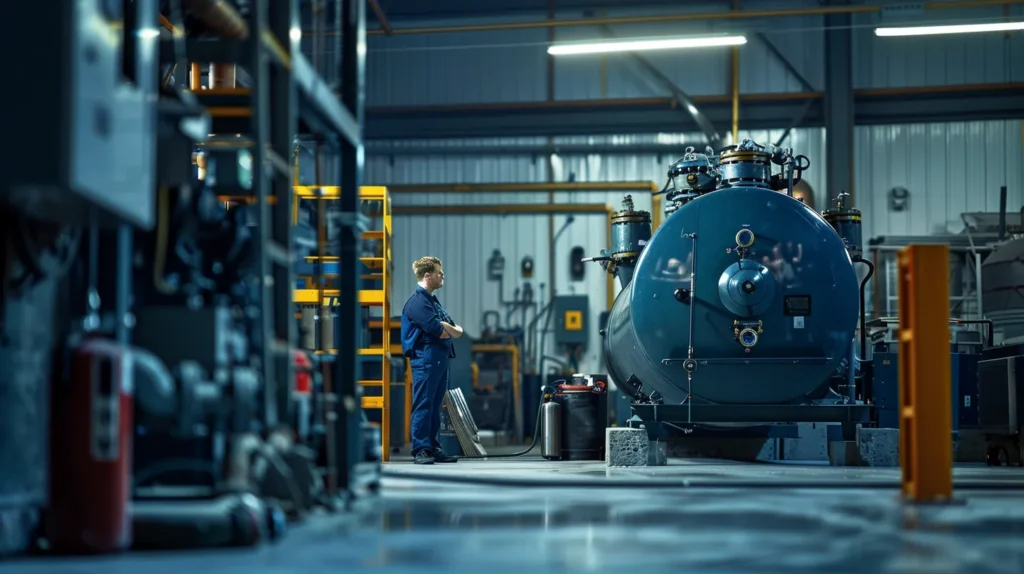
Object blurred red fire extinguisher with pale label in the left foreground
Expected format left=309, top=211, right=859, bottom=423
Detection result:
left=46, top=338, right=134, bottom=554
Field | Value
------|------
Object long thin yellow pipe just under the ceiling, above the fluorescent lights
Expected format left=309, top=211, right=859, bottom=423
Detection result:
left=344, top=0, right=1024, bottom=36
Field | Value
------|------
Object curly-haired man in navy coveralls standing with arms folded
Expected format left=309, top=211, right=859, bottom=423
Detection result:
left=401, top=257, right=462, bottom=465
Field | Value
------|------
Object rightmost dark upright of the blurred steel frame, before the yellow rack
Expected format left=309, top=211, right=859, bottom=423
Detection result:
left=333, top=0, right=366, bottom=495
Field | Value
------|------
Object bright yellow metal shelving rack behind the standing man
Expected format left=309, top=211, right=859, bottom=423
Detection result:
left=293, top=185, right=393, bottom=462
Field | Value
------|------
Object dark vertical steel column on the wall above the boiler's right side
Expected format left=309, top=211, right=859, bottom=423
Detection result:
left=824, top=0, right=854, bottom=203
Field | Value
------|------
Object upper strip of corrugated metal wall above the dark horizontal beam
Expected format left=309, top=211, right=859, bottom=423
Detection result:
left=367, top=2, right=1024, bottom=106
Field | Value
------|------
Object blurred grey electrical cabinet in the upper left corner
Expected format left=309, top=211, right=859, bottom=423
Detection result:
left=0, top=0, right=160, bottom=228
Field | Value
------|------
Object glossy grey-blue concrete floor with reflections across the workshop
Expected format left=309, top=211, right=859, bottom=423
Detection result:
left=6, top=452, right=1024, bottom=574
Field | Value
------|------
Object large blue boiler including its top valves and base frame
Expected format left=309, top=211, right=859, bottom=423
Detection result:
left=591, top=140, right=870, bottom=432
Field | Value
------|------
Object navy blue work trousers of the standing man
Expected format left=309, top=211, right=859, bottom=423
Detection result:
left=409, top=345, right=449, bottom=454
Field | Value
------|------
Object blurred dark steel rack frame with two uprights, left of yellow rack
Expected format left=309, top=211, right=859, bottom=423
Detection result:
left=176, top=0, right=366, bottom=493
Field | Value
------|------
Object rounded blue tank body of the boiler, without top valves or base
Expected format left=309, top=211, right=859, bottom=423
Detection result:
left=604, top=187, right=859, bottom=404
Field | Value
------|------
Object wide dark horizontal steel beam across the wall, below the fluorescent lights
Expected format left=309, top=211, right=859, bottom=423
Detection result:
left=365, top=83, right=1024, bottom=139
